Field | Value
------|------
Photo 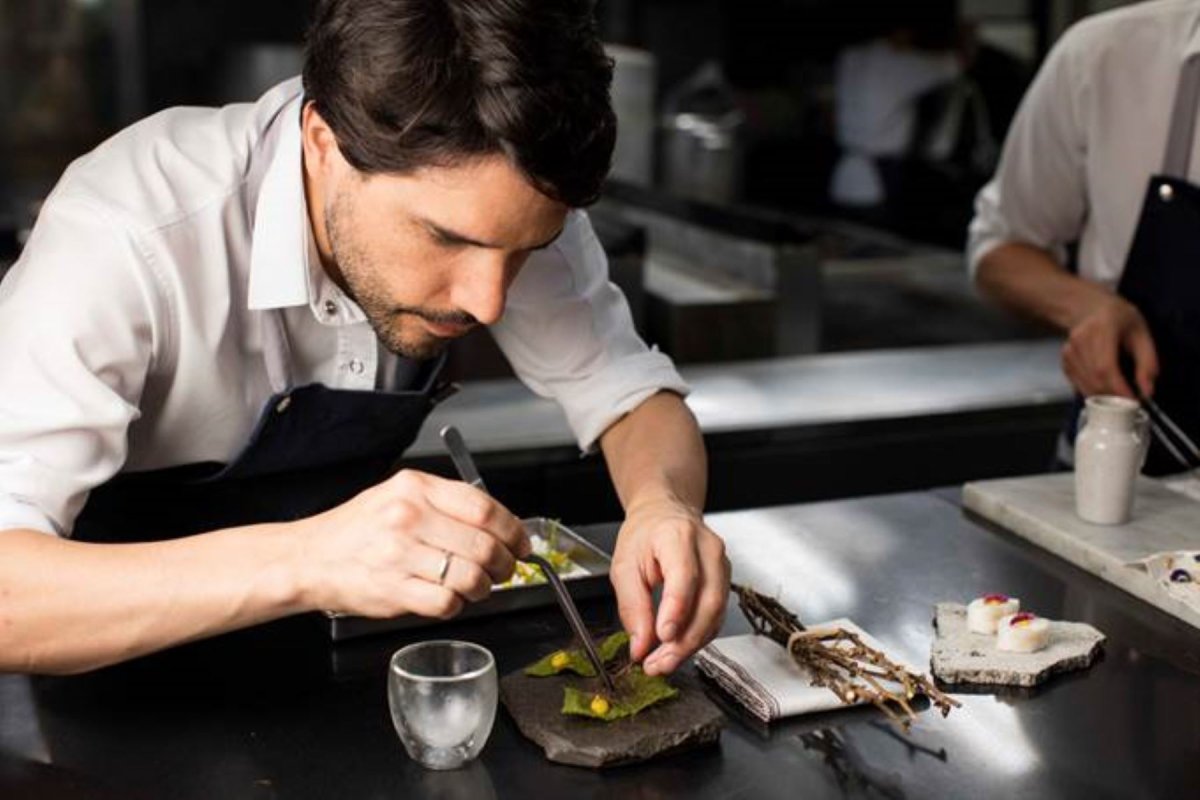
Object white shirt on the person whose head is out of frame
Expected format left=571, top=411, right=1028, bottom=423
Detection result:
left=968, top=0, right=1200, bottom=287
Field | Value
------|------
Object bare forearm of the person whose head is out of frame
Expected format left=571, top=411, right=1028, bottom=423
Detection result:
left=976, top=242, right=1115, bottom=331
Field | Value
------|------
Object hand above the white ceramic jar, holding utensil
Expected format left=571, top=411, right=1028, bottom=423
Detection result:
left=1062, top=295, right=1158, bottom=398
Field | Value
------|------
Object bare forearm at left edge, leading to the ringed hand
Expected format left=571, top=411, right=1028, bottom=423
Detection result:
left=0, top=525, right=304, bottom=673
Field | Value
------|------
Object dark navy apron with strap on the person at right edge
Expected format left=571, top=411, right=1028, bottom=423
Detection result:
left=1069, top=56, right=1200, bottom=475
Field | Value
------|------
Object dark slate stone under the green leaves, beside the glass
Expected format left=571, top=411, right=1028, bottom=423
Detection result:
left=500, top=667, right=725, bottom=768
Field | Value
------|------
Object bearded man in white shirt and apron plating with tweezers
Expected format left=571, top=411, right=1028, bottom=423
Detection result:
left=0, top=0, right=730, bottom=674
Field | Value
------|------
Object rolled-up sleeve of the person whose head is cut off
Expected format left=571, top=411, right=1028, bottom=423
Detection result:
left=967, top=30, right=1087, bottom=277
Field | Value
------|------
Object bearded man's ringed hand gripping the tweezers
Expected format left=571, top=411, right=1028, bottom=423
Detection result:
left=294, top=470, right=529, bottom=619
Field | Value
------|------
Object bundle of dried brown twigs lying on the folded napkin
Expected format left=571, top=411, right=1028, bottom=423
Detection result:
left=733, top=584, right=960, bottom=730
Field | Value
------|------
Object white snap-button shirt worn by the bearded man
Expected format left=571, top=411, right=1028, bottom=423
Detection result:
left=0, top=79, right=686, bottom=534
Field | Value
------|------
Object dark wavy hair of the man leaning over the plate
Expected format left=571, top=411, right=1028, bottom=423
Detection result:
left=304, top=0, right=617, bottom=207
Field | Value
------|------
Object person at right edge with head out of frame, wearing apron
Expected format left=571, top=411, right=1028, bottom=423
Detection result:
left=968, top=0, right=1200, bottom=475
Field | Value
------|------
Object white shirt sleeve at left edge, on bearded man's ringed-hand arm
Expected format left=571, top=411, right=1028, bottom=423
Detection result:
left=0, top=191, right=162, bottom=535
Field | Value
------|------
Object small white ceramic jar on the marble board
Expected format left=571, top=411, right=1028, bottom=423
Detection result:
left=1075, top=395, right=1150, bottom=525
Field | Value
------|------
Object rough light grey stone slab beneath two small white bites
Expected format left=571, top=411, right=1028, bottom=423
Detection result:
left=931, top=603, right=1104, bottom=686
